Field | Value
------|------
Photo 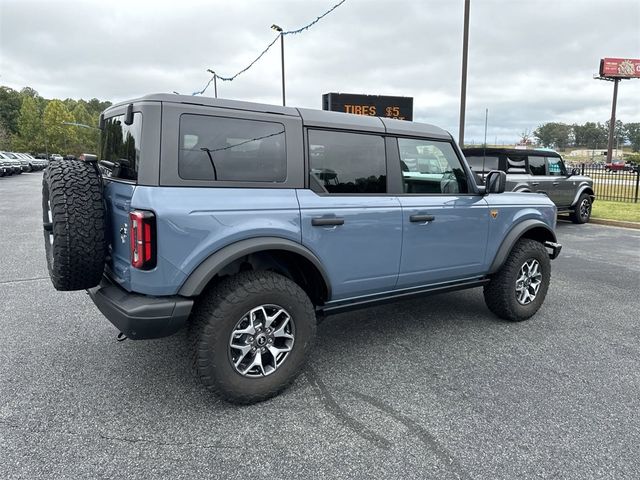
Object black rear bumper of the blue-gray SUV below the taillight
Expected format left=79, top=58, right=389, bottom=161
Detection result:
left=87, top=277, right=193, bottom=340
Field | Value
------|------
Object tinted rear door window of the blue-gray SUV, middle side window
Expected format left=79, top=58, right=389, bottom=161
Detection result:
left=309, top=130, right=387, bottom=193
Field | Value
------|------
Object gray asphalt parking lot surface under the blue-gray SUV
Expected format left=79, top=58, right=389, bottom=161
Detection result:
left=0, top=173, right=640, bottom=479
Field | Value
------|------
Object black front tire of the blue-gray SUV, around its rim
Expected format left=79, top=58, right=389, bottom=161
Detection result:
left=484, top=238, right=551, bottom=322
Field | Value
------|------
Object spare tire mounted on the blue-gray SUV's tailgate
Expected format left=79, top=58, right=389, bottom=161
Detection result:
left=42, top=160, right=107, bottom=291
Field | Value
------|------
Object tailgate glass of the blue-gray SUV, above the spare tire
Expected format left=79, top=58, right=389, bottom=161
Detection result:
left=100, top=112, right=142, bottom=181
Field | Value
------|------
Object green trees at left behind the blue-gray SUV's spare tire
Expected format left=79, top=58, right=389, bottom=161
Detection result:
left=0, top=86, right=111, bottom=155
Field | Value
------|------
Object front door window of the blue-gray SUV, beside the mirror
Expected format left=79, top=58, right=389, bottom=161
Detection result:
left=398, top=138, right=469, bottom=194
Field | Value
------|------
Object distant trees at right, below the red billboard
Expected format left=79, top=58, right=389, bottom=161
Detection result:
left=533, top=120, right=640, bottom=152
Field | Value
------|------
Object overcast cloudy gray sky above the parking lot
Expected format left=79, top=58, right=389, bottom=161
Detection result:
left=0, top=0, right=640, bottom=143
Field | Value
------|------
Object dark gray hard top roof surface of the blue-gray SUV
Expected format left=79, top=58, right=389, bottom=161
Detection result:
left=105, top=93, right=451, bottom=140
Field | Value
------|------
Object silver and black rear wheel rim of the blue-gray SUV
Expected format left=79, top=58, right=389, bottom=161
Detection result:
left=229, top=304, right=295, bottom=377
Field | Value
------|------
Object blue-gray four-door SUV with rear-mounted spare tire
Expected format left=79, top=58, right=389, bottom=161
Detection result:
left=42, top=94, right=561, bottom=403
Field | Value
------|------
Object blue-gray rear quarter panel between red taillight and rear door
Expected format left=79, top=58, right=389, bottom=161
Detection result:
left=131, top=186, right=301, bottom=295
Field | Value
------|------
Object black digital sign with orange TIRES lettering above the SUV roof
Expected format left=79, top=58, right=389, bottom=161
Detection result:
left=322, top=93, right=413, bottom=121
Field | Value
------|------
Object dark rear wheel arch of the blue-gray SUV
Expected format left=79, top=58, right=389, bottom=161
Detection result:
left=178, top=237, right=331, bottom=304
